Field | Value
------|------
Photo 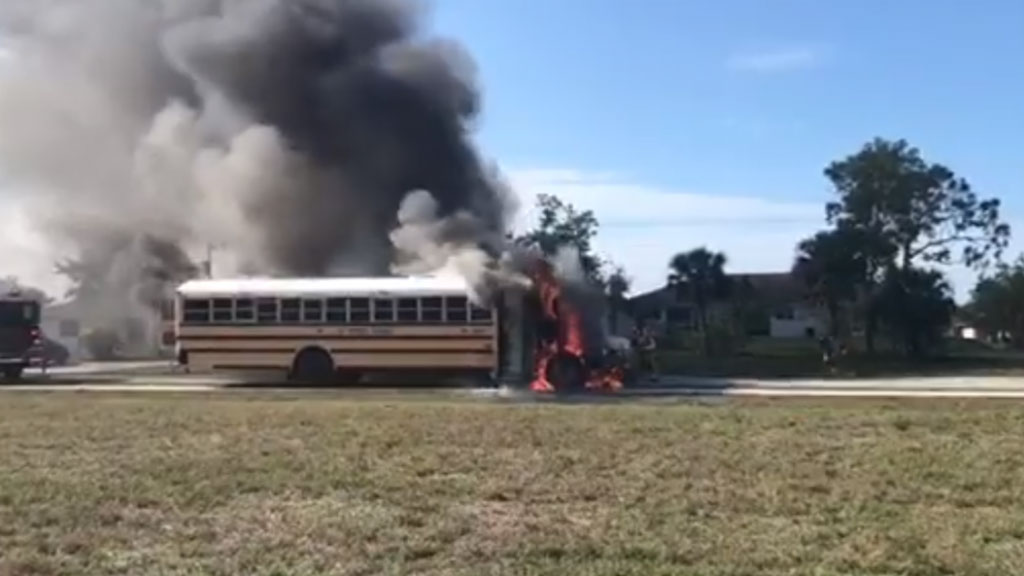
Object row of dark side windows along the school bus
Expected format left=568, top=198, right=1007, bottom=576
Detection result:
left=182, top=296, right=492, bottom=324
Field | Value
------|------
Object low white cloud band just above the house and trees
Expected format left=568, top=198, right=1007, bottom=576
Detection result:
left=509, top=169, right=1024, bottom=300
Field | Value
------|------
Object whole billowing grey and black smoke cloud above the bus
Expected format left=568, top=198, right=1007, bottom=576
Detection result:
left=0, top=0, right=524, bottom=311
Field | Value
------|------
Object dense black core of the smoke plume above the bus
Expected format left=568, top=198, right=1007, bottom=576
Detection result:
left=164, top=0, right=506, bottom=275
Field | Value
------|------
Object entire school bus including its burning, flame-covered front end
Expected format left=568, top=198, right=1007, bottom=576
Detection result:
left=175, top=266, right=625, bottom=392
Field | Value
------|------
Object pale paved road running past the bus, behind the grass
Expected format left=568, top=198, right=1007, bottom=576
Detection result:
left=6, top=361, right=1024, bottom=399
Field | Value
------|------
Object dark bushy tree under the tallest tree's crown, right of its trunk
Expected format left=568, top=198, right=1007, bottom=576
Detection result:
left=877, top=266, right=956, bottom=358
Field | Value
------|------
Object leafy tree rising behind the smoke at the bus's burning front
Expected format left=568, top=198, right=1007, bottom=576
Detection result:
left=516, top=194, right=604, bottom=285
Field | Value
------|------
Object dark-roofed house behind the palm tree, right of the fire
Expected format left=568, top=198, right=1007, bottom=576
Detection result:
left=630, top=273, right=827, bottom=338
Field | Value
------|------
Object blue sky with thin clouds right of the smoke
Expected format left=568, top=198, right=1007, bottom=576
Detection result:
left=433, top=0, right=1024, bottom=295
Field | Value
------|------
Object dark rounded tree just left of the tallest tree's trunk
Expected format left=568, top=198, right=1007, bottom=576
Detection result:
left=793, top=227, right=866, bottom=337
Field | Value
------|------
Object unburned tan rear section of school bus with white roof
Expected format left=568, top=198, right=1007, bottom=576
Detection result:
left=175, top=277, right=499, bottom=381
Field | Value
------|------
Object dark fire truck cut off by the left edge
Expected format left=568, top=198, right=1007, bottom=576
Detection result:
left=0, top=292, right=41, bottom=380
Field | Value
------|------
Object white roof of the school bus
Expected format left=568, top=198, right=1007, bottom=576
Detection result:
left=177, top=276, right=469, bottom=298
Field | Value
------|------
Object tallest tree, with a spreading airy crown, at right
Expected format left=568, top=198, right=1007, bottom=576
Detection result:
left=824, top=138, right=1010, bottom=352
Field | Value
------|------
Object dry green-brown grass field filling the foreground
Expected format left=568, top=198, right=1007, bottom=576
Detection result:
left=0, top=394, right=1024, bottom=576
